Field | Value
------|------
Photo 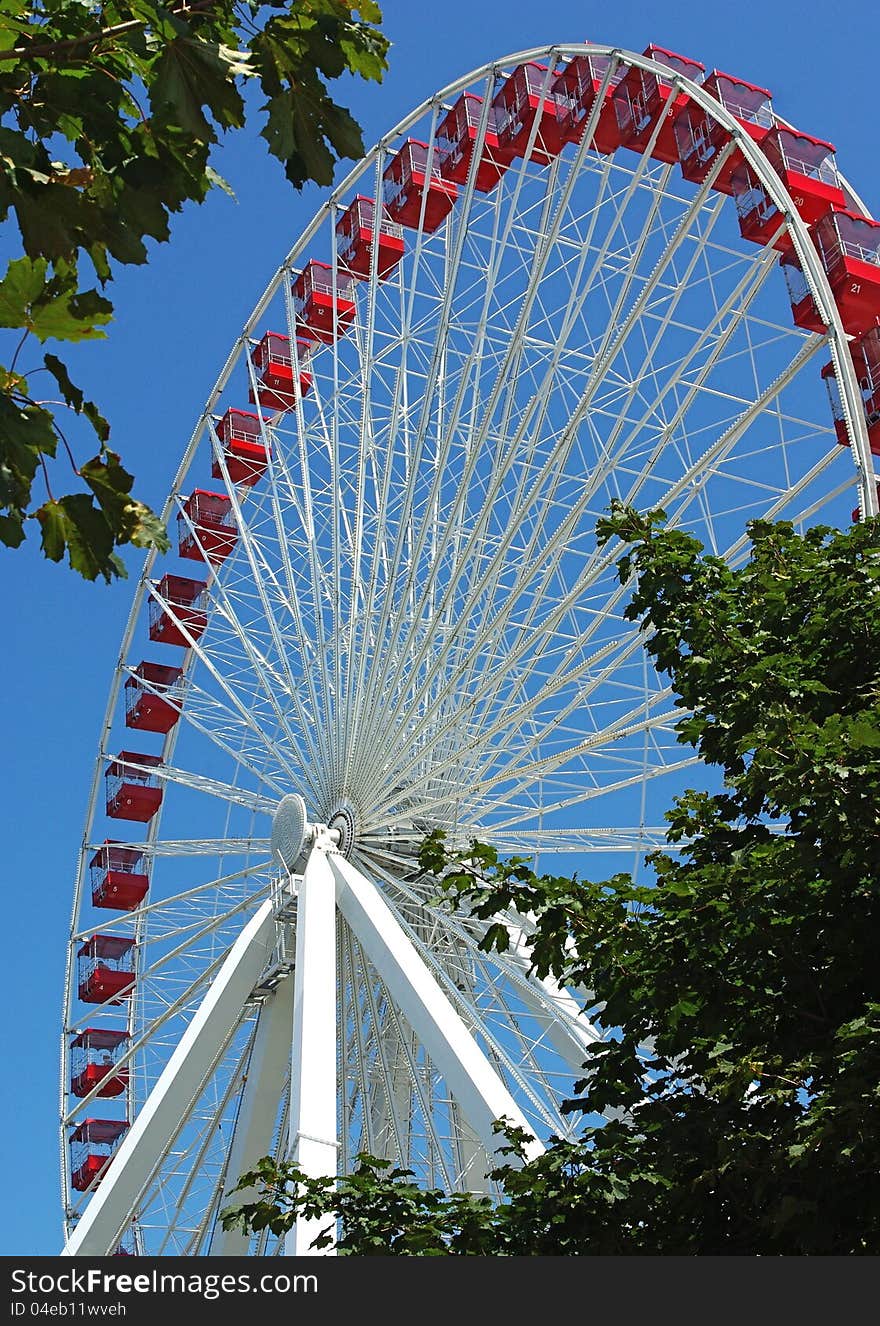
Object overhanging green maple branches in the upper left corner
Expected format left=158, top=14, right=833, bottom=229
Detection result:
left=0, top=0, right=388, bottom=581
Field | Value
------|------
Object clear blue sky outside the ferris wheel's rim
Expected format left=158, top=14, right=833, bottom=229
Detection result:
left=0, top=0, right=880, bottom=1256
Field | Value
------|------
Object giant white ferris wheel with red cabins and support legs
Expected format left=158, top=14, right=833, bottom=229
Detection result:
left=60, top=44, right=880, bottom=1256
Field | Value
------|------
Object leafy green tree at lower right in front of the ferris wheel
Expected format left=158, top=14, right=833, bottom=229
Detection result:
left=225, top=507, right=880, bottom=1256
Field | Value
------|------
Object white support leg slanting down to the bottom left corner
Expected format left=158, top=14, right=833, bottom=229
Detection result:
left=61, top=899, right=276, bottom=1257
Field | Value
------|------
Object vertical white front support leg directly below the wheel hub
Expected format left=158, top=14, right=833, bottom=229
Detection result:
left=285, top=842, right=339, bottom=1257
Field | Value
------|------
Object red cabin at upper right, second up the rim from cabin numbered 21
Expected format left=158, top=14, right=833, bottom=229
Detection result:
left=675, top=69, right=775, bottom=196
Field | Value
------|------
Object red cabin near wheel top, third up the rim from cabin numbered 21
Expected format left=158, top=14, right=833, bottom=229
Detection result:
left=614, top=45, right=706, bottom=164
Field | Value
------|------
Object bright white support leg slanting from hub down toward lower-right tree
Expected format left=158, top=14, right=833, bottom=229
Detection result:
left=329, top=855, right=543, bottom=1158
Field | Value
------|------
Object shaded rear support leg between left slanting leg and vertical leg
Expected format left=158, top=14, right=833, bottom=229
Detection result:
left=208, top=976, right=293, bottom=1257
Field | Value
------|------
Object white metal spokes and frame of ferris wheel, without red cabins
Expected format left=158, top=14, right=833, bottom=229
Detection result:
left=61, top=45, right=876, bottom=1253
